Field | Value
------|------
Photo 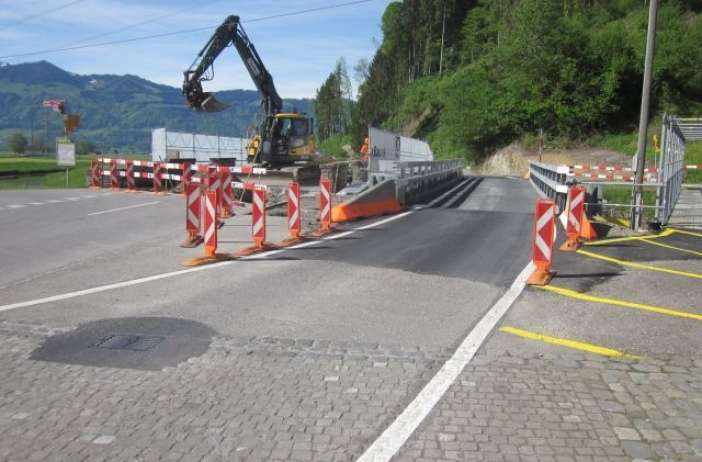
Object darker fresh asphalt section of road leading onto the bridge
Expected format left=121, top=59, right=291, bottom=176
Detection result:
left=288, top=209, right=532, bottom=287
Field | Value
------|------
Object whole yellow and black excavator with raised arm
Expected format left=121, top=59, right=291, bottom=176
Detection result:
left=183, top=15, right=319, bottom=176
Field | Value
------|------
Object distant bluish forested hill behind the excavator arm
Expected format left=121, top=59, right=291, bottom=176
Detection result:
left=0, top=61, right=312, bottom=152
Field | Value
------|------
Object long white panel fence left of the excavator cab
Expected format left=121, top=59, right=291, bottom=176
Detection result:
left=151, top=128, right=248, bottom=164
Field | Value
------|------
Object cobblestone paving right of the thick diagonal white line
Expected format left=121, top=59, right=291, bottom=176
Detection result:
left=396, top=350, right=702, bottom=461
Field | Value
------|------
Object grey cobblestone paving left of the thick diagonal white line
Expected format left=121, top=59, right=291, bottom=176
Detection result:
left=0, top=323, right=448, bottom=462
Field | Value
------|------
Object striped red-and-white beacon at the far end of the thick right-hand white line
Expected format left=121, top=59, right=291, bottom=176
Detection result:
left=527, top=199, right=556, bottom=286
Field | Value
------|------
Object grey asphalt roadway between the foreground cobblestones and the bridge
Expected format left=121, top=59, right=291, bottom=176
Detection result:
left=0, top=178, right=534, bottom=347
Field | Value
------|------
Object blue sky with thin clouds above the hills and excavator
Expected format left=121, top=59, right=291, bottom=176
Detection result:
left=0, top=0, right=390, bottom=97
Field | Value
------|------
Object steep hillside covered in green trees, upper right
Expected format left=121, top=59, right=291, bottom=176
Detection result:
left=320, top=0, right=702, bottom=160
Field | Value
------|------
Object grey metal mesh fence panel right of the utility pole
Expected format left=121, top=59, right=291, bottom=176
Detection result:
left=656, top=114, right=702, bottom=224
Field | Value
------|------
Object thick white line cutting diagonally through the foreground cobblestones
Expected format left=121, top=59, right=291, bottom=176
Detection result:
left=357, top=262, right=534, bottom=462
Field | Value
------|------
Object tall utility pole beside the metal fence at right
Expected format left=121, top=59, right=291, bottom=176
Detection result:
left=631, top=0, right=658, bottom=231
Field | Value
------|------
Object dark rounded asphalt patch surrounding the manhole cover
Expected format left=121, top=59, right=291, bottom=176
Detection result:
left=30, top=317, right=217, bottom=370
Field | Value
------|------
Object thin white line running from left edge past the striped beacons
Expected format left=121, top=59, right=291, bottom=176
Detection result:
left=0, top=208, right=420, bottom=312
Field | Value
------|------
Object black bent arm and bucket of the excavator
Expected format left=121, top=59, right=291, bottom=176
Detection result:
left=183, top=16, right=283, bottom=116
